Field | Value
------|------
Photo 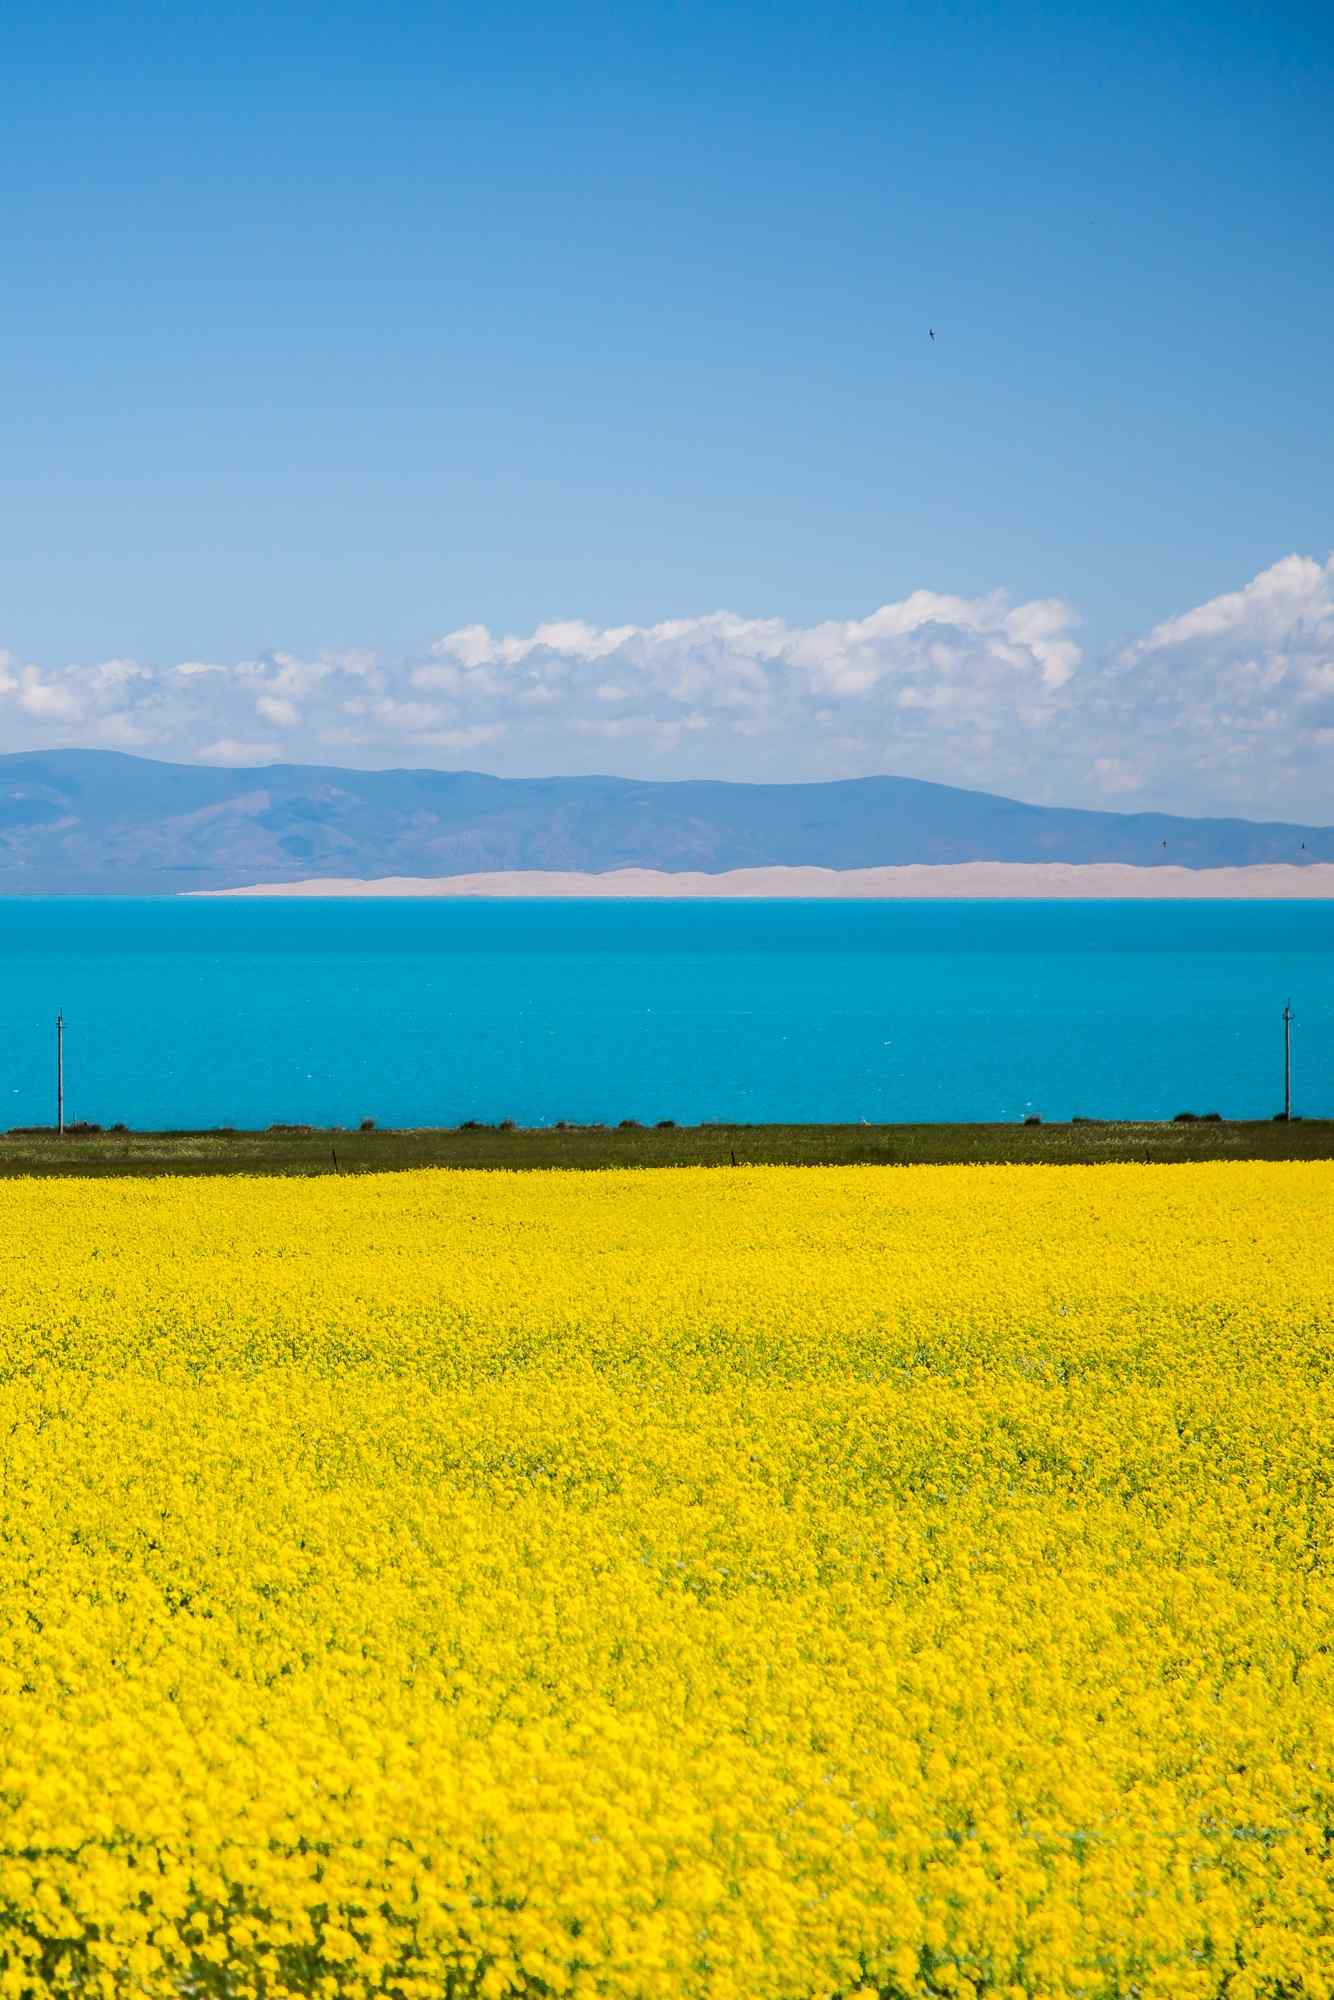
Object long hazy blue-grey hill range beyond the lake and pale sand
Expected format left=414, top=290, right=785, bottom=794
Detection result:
left=0, top=750, right=1334, bottom=896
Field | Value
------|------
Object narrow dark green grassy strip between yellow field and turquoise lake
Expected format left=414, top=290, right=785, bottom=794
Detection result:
left=0, top=1112, right=1334, bottom=1178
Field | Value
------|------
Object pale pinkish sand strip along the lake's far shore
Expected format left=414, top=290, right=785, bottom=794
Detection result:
left=194, top=862, right=1334, bottom=902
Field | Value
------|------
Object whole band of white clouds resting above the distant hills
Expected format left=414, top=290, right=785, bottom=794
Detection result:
left=0, top=556, right=1334, bottom=820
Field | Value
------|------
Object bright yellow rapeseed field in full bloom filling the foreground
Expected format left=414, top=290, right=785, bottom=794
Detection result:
left=0, top=1166, right=1334, bottom=2000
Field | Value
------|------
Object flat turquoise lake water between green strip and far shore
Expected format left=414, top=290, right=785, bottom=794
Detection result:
left=0, top=898, right=1334, bottom=1128
